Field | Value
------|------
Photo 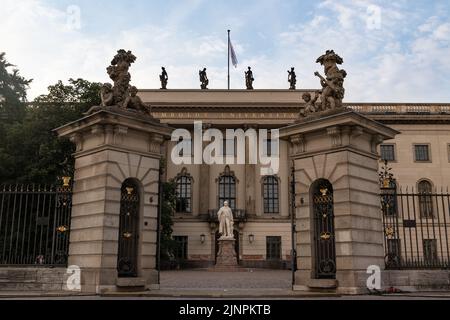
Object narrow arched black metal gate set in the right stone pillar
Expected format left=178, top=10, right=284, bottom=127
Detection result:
left=311, top=179, right=336, bottom=279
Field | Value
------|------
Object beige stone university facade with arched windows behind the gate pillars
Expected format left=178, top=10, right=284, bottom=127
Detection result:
left=139, top=90, right=450, bottom=268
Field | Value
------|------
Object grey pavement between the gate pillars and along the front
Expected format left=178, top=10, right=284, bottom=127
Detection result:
left=0, top=269, right=450, bottom=300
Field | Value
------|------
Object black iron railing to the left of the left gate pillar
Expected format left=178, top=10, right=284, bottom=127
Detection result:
left=0, top=180, right=72, bottom=266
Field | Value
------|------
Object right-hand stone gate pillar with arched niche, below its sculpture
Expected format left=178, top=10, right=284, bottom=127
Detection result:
left=280, top=110, right=398, bottom=294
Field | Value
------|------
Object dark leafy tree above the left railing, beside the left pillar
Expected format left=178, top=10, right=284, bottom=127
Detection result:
left=0, top=72, right=101, bottom=183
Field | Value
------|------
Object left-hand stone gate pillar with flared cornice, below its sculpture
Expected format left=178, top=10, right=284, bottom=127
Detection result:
left=55, top=108, right=172, bottom=293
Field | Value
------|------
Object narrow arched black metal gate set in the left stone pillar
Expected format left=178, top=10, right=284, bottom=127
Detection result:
left=117, top=179, right=139, bottom=277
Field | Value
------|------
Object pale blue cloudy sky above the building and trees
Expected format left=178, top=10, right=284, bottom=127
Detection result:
left=0, top=0, right=450, bottom=103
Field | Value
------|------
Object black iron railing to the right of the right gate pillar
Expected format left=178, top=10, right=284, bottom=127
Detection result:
left=380, top=161, right=450, bottom=269
